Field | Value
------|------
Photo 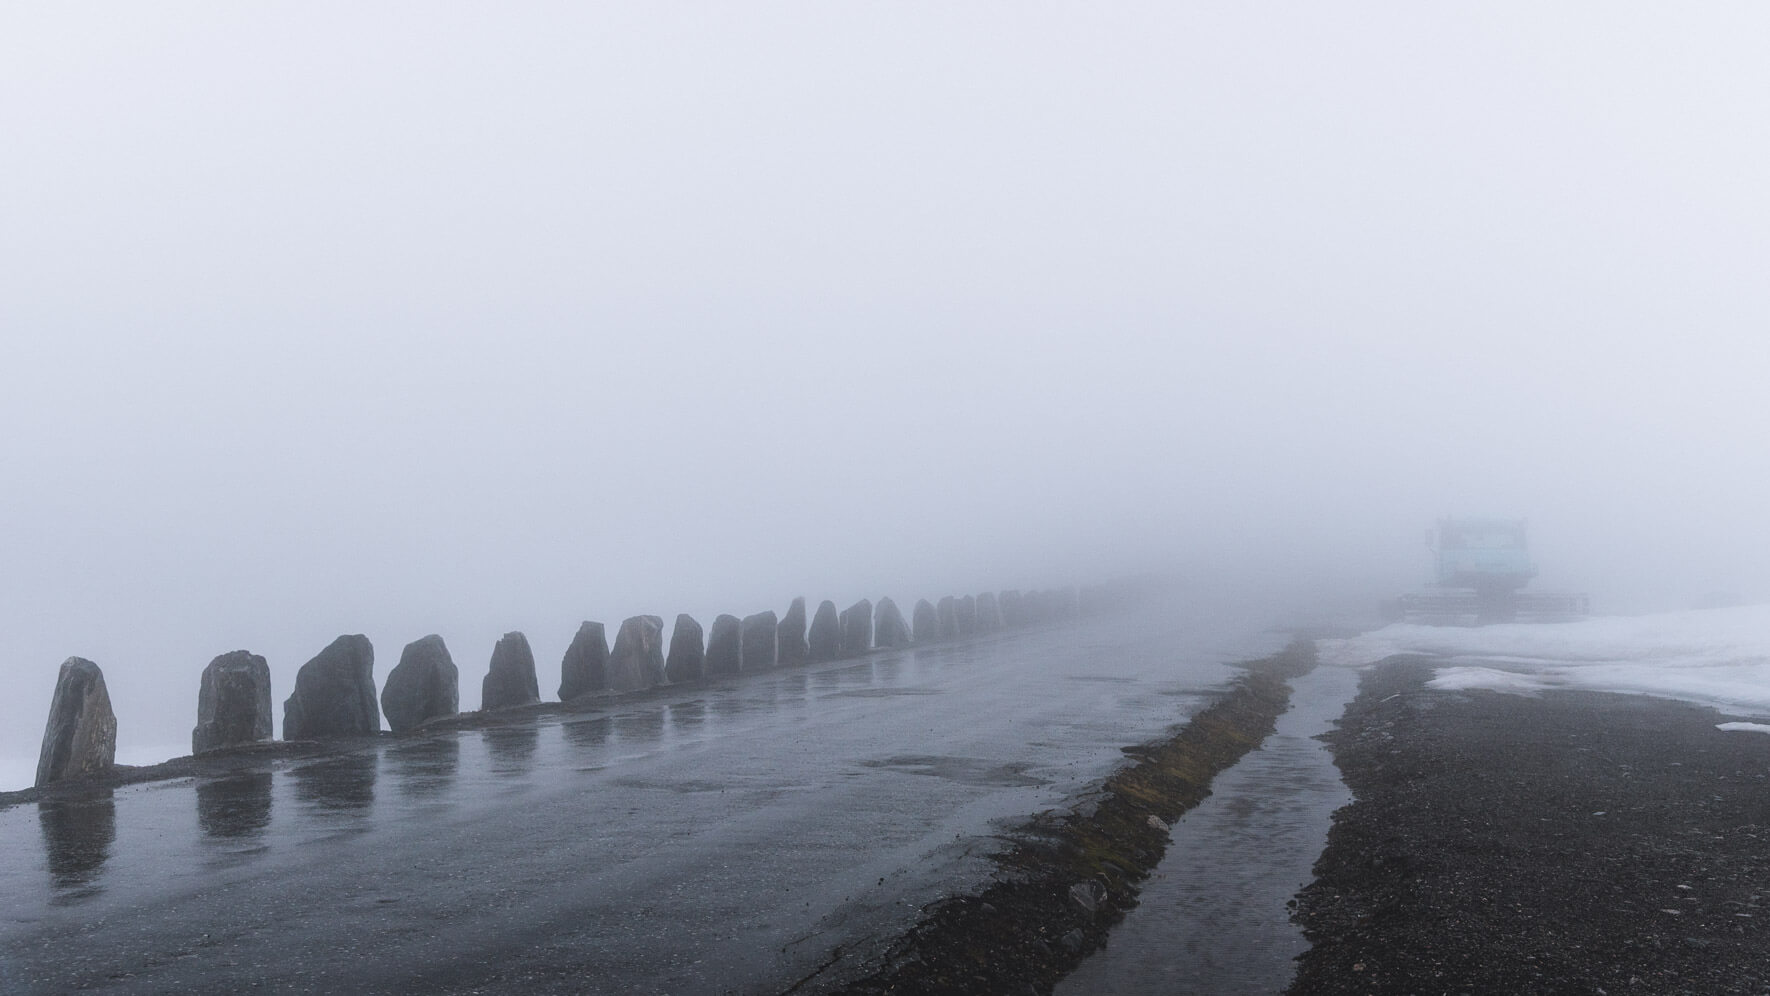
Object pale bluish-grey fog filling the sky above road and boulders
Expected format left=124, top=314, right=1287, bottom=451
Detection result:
left=0, top=4, right=1770, bottom=771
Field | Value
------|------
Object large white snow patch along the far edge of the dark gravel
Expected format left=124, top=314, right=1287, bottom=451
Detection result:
left=1319, top=605, right=1770, bottom=721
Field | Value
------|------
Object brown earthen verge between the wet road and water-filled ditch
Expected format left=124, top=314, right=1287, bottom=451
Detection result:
left=803, top=639, right=1315, bottom=996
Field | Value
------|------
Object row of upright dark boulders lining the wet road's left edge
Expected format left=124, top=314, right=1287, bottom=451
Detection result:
left=37, top=589, right=1104, bottom=785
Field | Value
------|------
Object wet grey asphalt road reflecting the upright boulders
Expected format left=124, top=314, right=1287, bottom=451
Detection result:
left=0, top=610, right=1283, bottom=994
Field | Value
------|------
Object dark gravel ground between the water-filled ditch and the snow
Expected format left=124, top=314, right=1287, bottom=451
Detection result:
left=1289, top=658, right=1770, bottom=996
